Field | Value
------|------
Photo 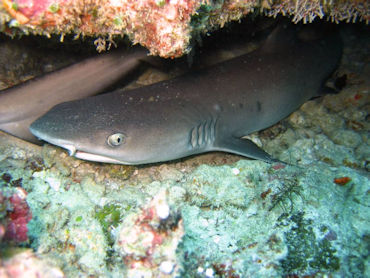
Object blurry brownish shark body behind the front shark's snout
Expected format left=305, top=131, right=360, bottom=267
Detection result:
left=0, top=47, right=148, bottom=143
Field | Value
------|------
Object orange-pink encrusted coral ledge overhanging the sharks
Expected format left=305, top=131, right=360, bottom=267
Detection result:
left=0, top=0, right=370, bottom=57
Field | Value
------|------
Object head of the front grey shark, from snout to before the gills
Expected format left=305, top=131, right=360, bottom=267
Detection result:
left=30, top=98, right=169, bottom=164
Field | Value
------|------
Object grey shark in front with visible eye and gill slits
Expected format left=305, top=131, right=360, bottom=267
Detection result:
left=31, top=25, right=341, bottom=164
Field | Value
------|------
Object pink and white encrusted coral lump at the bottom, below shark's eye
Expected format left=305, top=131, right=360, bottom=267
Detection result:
left=116, top=190, right=184, bottom=277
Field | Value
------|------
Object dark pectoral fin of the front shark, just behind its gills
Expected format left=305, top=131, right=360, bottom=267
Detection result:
left=215, top=137, right=281, bottom=163
